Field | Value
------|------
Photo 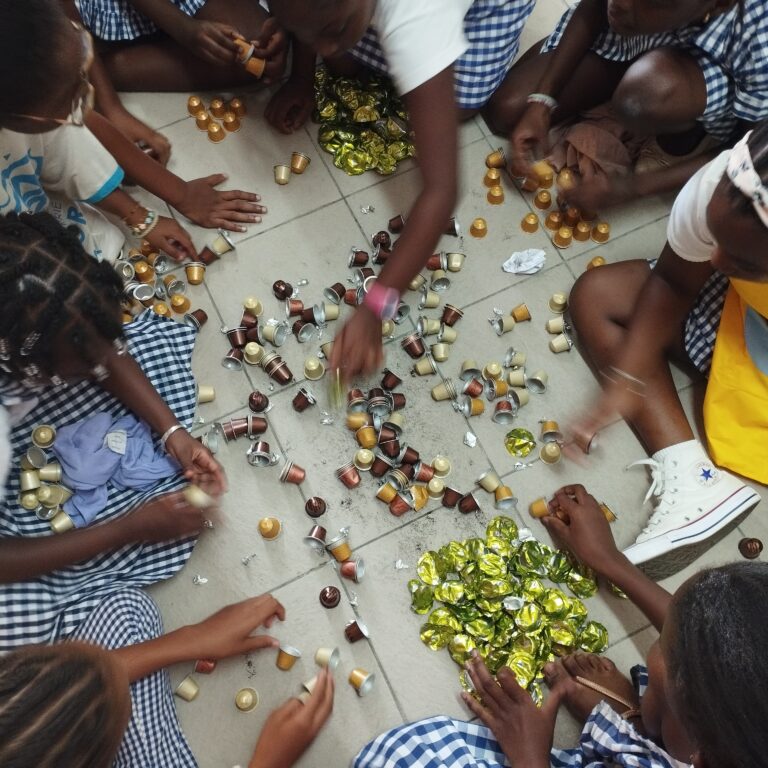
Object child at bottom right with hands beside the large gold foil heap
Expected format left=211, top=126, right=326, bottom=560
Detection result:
left=354, top=485, right=768, bottom=768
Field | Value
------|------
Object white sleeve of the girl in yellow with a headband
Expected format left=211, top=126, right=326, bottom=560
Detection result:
left=667, top=149, right=730, bottom=261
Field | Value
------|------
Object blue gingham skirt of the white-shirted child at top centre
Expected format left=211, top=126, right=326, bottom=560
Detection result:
left=350, top=0, right=536, bottom=109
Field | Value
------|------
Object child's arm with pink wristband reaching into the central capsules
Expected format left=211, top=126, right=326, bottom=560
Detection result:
left=330, top=67, right=458, bottom=380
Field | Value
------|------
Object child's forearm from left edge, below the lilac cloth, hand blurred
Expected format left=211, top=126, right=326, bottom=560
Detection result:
left=0, top=493, right=203, bottom=584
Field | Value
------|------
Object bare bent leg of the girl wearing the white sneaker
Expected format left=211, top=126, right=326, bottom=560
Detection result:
left=569, top=260, right=693, bottom=455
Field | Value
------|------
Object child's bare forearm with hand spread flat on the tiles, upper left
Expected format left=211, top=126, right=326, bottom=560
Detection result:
left=86, top=112, right=267, bottom=232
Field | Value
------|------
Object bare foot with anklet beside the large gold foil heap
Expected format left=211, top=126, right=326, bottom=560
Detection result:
left=544, top=653, right=640, bottom=723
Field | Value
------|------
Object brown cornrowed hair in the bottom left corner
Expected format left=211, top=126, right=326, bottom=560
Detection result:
left=0, top=643, right=129, bottom=768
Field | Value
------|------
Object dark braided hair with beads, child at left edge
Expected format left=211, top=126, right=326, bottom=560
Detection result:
left=0, top=213, right=123, bottom=387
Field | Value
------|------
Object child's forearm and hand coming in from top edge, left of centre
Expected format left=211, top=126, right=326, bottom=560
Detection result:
left=129, top=0, right=242, bottom=66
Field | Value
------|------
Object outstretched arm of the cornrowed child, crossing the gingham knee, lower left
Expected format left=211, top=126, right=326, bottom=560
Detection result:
left=112, top=595, right=285, bottom=682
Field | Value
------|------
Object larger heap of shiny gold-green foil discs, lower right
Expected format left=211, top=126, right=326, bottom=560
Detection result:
left=408, top=516, right=608, bottom=705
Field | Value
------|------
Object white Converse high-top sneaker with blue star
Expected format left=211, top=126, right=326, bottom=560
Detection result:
left=624, top=440, right=760, bottom=564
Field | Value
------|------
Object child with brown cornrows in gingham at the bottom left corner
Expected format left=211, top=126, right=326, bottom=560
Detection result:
left=0, top=589, right=333, bottom=768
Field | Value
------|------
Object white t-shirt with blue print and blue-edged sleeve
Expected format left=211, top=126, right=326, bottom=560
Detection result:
left=0, top=125, right=125, bottom=261
